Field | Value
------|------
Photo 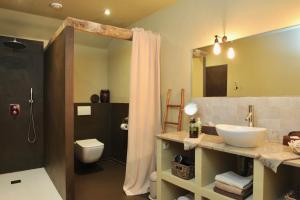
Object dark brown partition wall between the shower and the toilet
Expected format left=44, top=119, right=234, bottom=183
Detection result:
left=44, top=27, right=74, bottom=200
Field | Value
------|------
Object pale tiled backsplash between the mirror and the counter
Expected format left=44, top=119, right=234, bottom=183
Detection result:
left=193, top=97, right=300, bottom=142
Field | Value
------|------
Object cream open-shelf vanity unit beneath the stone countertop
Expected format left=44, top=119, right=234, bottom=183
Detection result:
left=157, top=135, right=300, bottom=200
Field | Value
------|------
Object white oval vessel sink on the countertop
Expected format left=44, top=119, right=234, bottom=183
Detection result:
left=216, top=124, right=267, bottom=147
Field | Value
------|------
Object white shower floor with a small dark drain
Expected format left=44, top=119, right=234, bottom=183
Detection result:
left=0, top=168, right=62, bottom=200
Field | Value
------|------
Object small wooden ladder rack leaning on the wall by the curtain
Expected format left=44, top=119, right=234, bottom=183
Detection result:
left=162, top=89, right=184, bottom=133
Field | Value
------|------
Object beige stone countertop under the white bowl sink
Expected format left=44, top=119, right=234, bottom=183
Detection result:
left=157, top=131, right=300, bottom=167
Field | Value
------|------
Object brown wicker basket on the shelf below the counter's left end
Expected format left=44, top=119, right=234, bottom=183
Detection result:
left=172, top=161, right=195, bottom=180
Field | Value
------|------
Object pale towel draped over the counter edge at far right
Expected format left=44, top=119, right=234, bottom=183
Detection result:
left=258, top=152, right=300, bottom=173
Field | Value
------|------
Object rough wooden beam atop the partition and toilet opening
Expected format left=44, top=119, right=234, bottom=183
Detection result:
left=46, top=17, right=133, bottom=49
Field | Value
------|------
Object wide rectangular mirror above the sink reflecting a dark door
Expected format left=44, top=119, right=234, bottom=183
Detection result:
left=191, top=26, right=300, bottom=97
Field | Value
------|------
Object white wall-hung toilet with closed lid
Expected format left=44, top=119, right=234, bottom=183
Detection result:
left=75, top=139, right=104, bottom=163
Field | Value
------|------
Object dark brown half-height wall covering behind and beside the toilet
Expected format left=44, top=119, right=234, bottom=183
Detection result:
left=74, top=103, right=129, bottom=163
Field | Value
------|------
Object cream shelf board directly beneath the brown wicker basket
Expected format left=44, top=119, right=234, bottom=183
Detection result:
left=161, top=169, right=197, bottom=193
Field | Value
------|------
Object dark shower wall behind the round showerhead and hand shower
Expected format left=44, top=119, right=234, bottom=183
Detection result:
left=0, top=36, right=44, bottom=174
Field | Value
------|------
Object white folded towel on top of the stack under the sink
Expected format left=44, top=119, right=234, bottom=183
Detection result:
left=215, top=171, right=253, bottom=189
